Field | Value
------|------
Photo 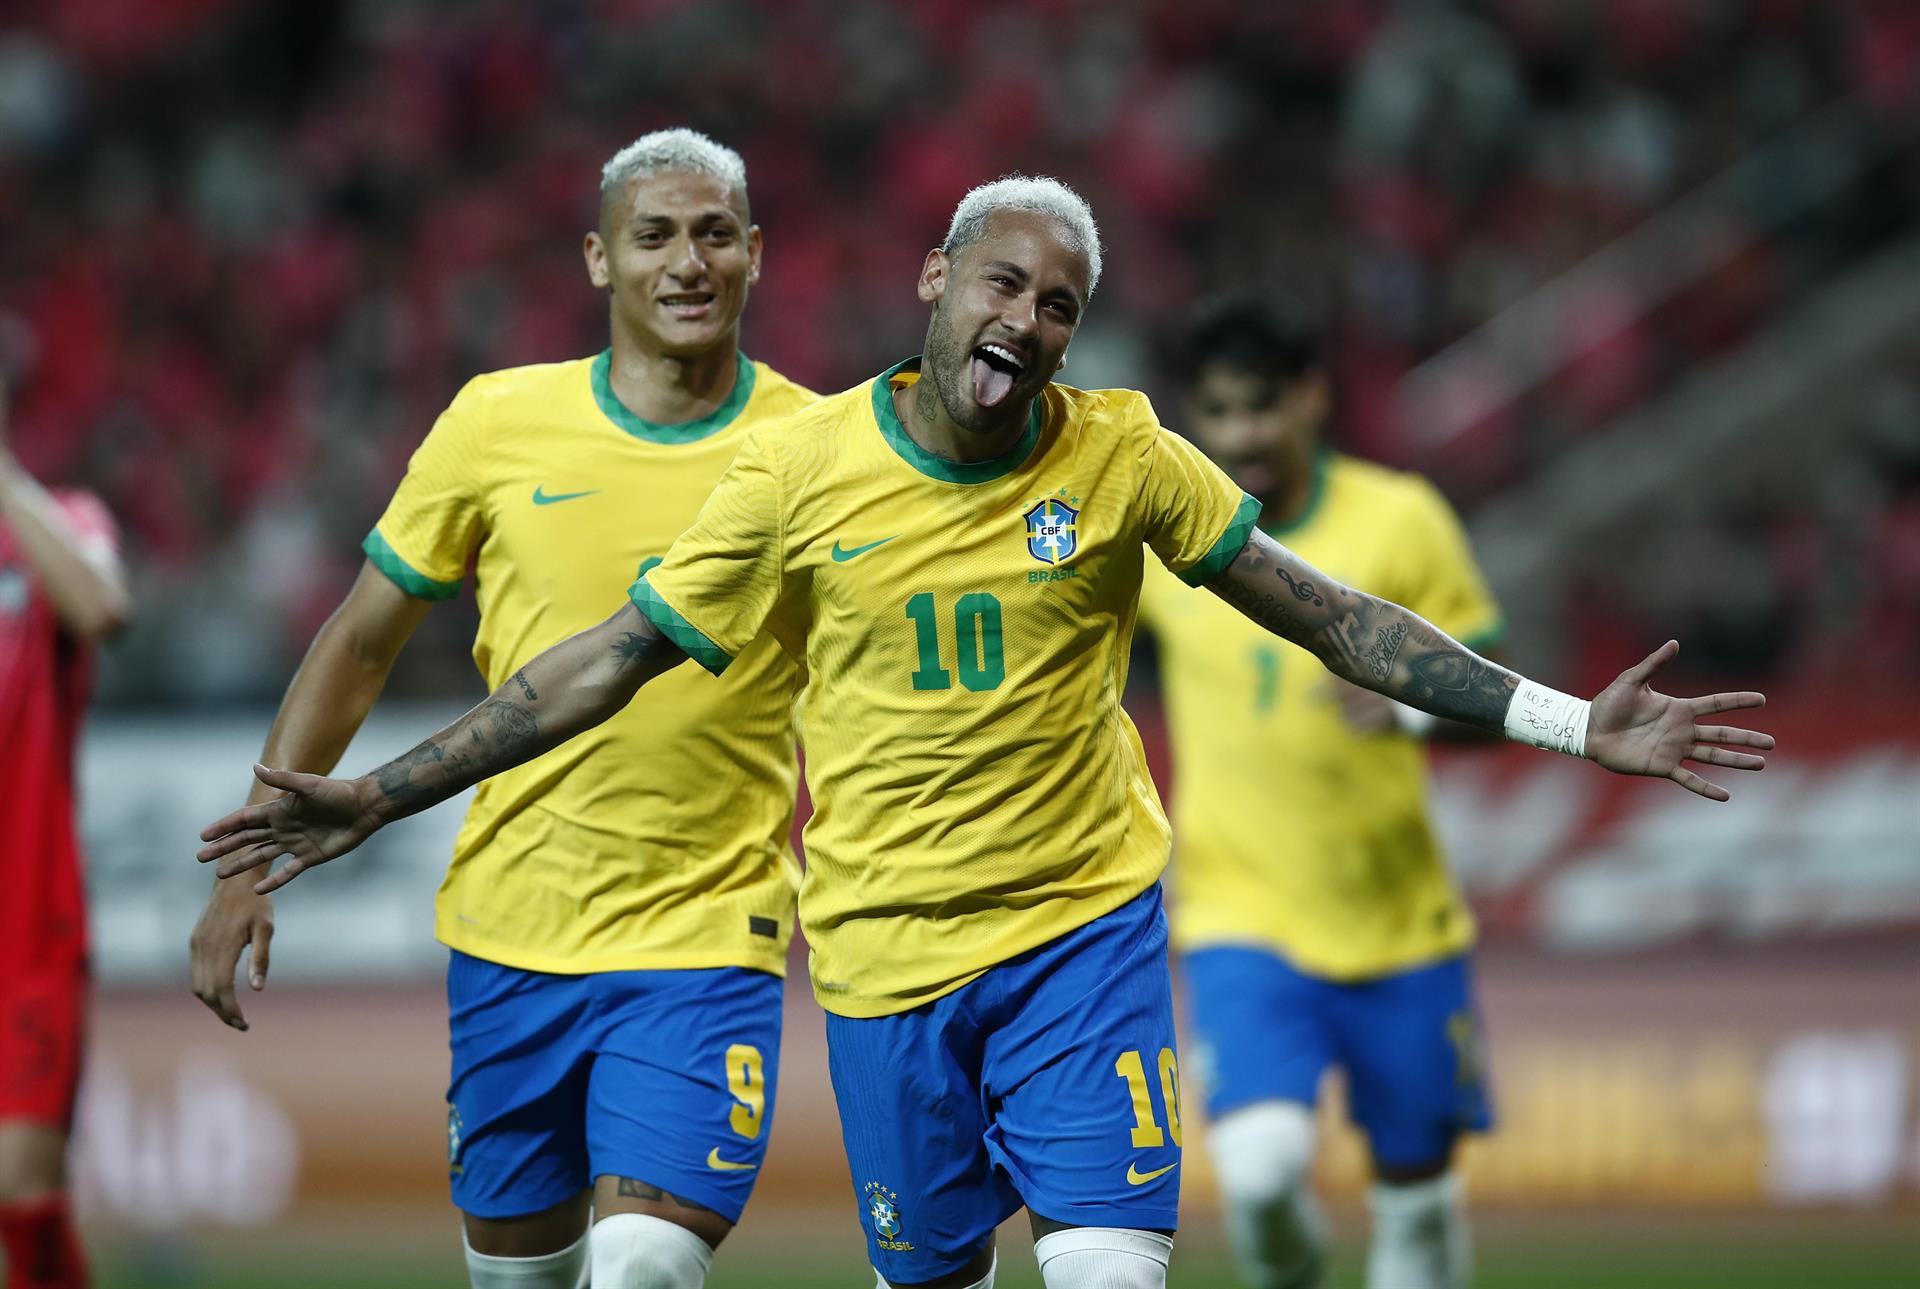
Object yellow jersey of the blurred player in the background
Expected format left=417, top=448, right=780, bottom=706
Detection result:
left=1140, top=453, right=1501, bottom=980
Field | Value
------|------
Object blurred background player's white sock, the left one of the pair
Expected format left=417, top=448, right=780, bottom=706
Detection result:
left=1208, top=1101, right=1327, bottom=1289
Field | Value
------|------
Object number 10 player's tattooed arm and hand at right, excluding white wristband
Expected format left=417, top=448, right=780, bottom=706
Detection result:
left=1208, top=528, right=1774, bottom=801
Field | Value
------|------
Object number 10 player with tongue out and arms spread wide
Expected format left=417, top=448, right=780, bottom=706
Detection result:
left=200, top=175, right=1770, bottom=1289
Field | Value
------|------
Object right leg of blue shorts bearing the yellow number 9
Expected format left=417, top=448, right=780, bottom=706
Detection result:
left=588, top=966, right=785, bottom=1237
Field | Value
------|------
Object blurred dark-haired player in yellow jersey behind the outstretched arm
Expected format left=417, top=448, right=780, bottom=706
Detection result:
left=1140, top=298, right=1501, bottom=1289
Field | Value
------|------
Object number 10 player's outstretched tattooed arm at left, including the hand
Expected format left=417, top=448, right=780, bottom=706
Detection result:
left=200, top=603, right=685, bottom=893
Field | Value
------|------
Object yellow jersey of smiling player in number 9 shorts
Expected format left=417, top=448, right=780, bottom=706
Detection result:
left=365, top=353, right=814, bottom=974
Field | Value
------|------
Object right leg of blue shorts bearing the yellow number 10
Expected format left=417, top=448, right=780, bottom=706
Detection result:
left=987, top=888, right=1181, bottom=1231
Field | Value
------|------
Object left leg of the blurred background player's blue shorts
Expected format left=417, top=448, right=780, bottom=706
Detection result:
left=1181, top=945, right=1334, bottom=1118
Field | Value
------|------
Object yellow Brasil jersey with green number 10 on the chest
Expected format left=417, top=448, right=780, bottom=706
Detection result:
left=632, top=359, right=1260, bottom=1016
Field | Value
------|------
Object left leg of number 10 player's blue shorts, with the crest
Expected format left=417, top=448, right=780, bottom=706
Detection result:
left=826, top=982, right=1020, bottom=1285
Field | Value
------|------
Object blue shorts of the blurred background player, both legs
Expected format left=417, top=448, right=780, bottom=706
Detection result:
left=1181, top=945, right=1494, bottom=1168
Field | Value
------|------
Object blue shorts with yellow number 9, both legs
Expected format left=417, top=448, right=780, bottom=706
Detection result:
left=447, top=953, right=785, bottom=1222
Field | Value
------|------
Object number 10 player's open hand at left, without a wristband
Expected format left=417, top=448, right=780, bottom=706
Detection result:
left=198, top=765, right=382, bottom=895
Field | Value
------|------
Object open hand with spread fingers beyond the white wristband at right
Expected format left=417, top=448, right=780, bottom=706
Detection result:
left=1586, top=640, right=1774, bottom=801
